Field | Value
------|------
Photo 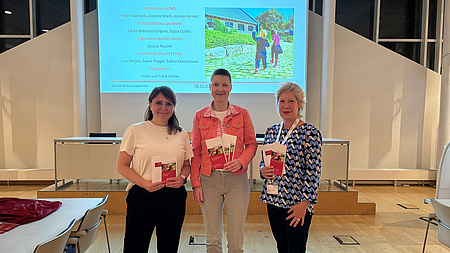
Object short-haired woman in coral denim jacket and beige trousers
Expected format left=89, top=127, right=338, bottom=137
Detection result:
left=191, top=69, right=257, bottom=253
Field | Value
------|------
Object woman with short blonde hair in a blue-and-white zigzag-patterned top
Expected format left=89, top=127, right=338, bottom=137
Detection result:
left=259, top=82, right=322, bottom=253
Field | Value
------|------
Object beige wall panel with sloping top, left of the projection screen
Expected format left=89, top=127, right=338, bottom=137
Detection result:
left=0, top=21, right=73, bottom=168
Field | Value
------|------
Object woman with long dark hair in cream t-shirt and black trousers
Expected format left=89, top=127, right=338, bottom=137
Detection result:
left=117, top=86, right=193, bottom=253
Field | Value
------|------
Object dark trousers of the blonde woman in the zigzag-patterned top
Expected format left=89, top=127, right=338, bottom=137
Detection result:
left=267, top=204, right=312, bottom=253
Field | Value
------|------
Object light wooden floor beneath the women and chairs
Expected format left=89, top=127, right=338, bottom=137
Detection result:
left=0, top=185, right=450, bottom=253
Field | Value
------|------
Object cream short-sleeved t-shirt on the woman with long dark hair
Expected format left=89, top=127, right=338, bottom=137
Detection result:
left=120, top=121, right=194, bottom=191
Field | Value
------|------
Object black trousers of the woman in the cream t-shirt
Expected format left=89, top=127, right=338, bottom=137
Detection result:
left=123, top=185, right=187, bottom=253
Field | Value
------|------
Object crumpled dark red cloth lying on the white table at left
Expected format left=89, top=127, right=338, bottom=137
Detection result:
left=0, top=198, right=62, bottom=225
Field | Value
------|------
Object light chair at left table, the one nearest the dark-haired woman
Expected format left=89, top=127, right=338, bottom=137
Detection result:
left=67, top=195, right=108, bottom=253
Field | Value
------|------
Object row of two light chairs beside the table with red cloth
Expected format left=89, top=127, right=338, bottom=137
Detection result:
left=34, top=195, right=111, bottom=253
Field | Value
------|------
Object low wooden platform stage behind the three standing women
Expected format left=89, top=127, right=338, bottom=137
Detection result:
left=37, top=179, right=376, bottom=215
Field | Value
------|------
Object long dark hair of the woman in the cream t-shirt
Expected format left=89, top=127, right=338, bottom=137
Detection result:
left=144, top=86, right=181, bottom=134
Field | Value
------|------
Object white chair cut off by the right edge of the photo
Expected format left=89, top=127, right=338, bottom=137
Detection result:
left=422, top=198, right=450, bottom=252
